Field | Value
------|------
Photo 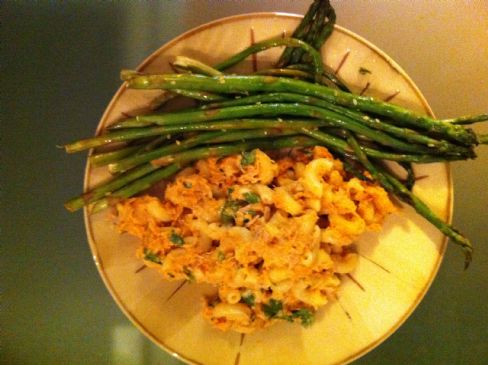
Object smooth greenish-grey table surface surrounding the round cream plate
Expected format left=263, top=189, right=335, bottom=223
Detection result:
left=0, top=0, right=488, bottom=365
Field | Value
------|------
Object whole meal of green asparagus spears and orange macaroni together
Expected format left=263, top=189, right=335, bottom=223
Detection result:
left=65, top=0, right=488, bottom=332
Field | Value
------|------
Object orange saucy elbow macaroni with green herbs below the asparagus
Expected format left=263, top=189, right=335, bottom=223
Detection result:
left=117, top=147, right=395, bottom=332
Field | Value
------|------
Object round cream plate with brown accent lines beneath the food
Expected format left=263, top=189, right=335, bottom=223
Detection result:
left=85, top=13, right=452, bottom=365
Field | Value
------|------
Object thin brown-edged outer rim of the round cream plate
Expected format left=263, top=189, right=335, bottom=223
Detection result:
left=83, top=12, right=454, bottom=365
